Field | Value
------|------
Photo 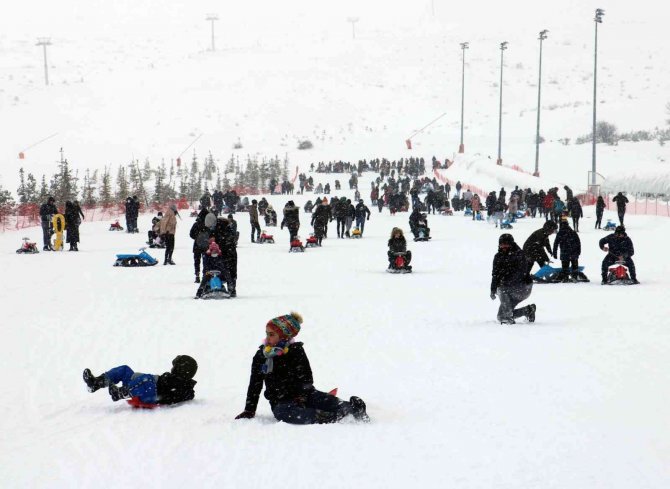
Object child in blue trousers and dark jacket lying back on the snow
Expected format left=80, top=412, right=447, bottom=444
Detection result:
left=83, top=355, right=198, bottom=405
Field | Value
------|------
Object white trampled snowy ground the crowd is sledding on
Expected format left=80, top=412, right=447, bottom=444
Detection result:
left=0, top=170, right=670, bottom=489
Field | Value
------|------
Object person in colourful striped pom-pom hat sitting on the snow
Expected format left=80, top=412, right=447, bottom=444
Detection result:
left=235, top=312, right=370, bottom=424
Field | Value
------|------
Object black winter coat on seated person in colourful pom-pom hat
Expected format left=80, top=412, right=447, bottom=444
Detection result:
left=244, top=343, right=314, bottom=413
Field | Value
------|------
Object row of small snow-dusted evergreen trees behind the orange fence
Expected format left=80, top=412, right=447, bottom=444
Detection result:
left=5, top=152, right=288, bottom=207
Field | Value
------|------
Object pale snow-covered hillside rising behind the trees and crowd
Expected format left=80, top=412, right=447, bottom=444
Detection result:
left=0, top=0, right=670, bottom=191
